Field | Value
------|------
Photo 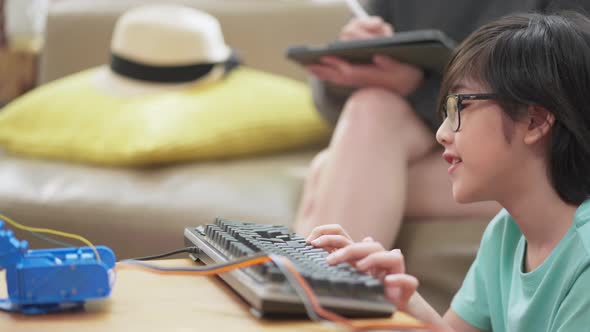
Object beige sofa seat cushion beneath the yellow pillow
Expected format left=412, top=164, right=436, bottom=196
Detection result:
left=0, top=151, right=316, bottom=259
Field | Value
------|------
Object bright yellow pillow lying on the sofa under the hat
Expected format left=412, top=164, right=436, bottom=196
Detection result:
left=0, top=67, right=330, bottom=166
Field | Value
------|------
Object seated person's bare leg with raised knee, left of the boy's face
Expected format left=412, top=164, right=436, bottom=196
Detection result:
left=295, top=88, right=435, bottom=243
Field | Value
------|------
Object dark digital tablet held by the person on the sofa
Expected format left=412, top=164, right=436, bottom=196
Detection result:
left=287, top=30, right=457, bottom=73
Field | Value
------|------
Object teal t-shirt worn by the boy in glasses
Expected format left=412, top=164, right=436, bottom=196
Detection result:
left=451, top=200, right=590, bottom=332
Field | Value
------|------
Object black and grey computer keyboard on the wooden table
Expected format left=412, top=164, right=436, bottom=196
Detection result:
left=184, top=218, right=394, bottom=317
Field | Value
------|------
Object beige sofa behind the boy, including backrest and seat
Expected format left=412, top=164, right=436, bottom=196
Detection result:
left=0, top=0, right=487, bottom=311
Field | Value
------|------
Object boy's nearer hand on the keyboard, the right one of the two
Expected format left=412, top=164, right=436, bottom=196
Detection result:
left=326, top=239, right=418, bottom=310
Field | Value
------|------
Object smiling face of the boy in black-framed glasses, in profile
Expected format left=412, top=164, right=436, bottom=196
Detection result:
left=436, top=80, right=520, bottom=203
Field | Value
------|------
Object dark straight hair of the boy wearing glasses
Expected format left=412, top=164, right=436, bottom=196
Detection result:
left=438, top=12, right=590, bottom=205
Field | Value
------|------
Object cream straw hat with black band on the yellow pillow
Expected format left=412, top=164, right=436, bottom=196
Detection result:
left=95, top=4, right=236, bottom=96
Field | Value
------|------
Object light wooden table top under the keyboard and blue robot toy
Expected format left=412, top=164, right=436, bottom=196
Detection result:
left=0, top=259, right=426, bottom=332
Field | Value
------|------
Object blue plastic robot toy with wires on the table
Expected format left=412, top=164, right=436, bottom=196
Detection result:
left=0, top=220, right=116, bottom=315
